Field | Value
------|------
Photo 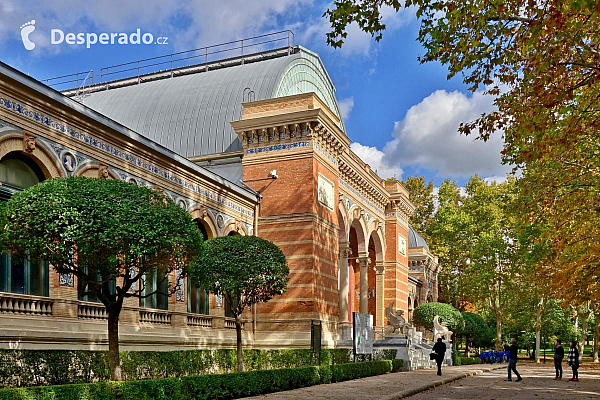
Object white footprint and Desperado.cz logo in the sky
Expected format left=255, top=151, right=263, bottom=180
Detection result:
left=20, top=20, right=169, bottom=50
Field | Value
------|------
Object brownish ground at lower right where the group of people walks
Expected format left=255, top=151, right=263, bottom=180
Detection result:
left=410, top=362, right=600, bottom=400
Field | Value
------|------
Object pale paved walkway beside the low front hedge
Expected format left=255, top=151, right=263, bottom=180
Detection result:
left=244, top=364, right=505, bottom=400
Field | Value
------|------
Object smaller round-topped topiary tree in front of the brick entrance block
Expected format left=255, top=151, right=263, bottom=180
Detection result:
left=190, top=236, right=290, bottom=371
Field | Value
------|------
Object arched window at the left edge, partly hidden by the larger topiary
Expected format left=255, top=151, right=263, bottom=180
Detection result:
left=0, top=152, right=49, bottom=296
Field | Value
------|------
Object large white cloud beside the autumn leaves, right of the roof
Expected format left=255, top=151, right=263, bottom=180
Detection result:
left=383, top=90, right=510, bottom=177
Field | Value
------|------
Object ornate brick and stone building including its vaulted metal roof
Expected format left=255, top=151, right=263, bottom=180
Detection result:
left=0, top=40, right=439, bottom=350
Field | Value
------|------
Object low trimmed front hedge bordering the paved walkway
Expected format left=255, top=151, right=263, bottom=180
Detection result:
left=0, top=360, right=401, bottom=400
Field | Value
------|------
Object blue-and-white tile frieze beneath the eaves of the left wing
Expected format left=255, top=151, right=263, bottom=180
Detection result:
left=0, top=97, right=254, bottom=217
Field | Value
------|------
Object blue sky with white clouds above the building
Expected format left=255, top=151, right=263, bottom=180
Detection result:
left=0, top=0, right=509, bottom=186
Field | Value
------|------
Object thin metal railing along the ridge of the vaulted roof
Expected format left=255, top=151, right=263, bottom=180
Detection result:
left=41, top=29, right=294, bottom=90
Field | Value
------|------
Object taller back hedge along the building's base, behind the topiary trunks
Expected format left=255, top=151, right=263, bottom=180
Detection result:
left=0, top=349, right=354, bottom=387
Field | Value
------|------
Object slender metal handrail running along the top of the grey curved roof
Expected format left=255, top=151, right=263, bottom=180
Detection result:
left=41, top=29, right=295, bottom=89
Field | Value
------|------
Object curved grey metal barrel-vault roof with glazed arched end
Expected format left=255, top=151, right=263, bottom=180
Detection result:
left=72, top=46, right=344, bottom=158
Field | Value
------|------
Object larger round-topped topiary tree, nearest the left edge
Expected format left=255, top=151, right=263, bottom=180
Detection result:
left=1, top=177, right=202, bottom=381
